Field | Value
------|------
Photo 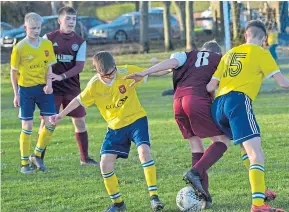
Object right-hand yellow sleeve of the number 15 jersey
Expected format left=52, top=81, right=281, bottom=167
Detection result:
left=259, top=50, right=280, bottom=79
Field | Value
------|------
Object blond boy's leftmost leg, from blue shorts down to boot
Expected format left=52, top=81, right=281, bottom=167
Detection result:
left=19, top=87, right=35, bottom=174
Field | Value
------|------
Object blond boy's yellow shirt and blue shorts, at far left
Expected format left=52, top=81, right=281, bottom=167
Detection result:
left=11, top=38, right=56, bottom=120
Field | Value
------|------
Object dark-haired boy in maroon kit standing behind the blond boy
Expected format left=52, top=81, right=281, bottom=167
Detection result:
left=40, top=7, right=99, bottom=166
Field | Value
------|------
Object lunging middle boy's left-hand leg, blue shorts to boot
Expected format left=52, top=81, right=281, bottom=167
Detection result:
left=100, top=126, right=130, bottom=212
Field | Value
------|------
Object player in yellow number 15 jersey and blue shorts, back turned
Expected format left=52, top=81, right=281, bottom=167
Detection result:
left=207, top=20, right=289, bottom=212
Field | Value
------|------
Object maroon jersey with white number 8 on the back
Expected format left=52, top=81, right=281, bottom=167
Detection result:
left=173, top=51, right=221, bottom=98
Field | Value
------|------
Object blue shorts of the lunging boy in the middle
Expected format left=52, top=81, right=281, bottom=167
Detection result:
left=100, top=117, right=150, bottom=158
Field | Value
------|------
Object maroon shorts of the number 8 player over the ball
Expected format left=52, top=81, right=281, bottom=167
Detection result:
left=174, top=95, right=223, bottom=139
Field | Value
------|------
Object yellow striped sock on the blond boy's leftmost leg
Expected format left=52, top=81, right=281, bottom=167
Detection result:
left=19, top=129, right=32, bottom=166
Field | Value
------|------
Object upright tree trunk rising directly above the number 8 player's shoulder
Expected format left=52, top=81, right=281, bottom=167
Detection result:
left=186, top=0, right=197, bottom=51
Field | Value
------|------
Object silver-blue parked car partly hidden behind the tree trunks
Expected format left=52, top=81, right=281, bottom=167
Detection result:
left=87, top=8, right=180, bottom=43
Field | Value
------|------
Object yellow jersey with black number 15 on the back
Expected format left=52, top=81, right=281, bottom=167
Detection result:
left=212, top=44, right=280, bottom=101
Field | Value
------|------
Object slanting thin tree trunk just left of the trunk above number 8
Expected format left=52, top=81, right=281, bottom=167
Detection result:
left=173, top=1, right=186, bottom=44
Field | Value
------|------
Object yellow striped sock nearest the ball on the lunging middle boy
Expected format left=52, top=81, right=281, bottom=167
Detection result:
left=142, top=160, right=158, bottom=197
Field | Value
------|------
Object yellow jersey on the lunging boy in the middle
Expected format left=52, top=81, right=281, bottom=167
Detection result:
left=77, top=65, right=146, bottom=130
